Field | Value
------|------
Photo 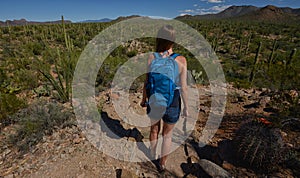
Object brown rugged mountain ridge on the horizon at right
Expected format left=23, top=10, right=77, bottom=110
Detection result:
left=176, top=5, right=300, bottom=22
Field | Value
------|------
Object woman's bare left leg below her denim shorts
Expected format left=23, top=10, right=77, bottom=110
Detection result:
left=150, top=120, right=160, bottom=158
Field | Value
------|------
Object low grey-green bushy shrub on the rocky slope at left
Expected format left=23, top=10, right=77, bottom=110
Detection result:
left=10, top=99, right=75, bottom=152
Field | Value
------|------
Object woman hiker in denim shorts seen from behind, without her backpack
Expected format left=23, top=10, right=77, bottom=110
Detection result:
left=141, top=25, right=188, bottom=172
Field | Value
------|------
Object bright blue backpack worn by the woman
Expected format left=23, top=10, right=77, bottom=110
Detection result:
left=146, top=53, right=179, bottom=109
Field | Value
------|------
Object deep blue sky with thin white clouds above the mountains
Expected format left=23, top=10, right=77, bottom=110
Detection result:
left=0, top=0, right=300, bottom=22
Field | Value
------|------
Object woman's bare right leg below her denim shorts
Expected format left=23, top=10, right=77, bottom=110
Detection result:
left=160, top=123, right=175, bottom=165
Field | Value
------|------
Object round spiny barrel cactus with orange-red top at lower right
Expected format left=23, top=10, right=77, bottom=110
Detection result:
left=233, top=118, right=287, bottom=173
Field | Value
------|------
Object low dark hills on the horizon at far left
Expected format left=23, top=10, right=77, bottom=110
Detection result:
left=0, top=19, right=72, bottom=27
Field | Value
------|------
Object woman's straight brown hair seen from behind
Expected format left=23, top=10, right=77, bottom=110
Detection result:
left=156, top=25, right=175, bottom=52
